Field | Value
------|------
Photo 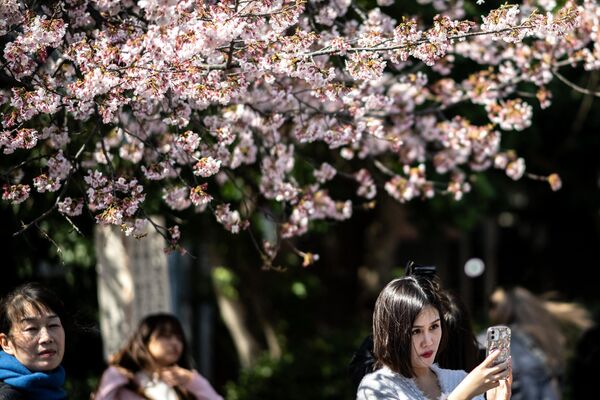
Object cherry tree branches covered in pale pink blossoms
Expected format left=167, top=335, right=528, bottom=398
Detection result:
left=0, top=0, right=600, bottom=266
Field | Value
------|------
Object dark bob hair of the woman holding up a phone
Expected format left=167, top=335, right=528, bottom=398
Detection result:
left=373, top=276, right=446, bottom=378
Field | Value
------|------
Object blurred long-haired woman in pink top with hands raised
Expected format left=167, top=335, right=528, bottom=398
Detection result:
left=94, top=313, right=223, bottom=400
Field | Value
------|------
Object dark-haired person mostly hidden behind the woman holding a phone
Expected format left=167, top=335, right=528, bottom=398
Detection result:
left=348, top=261, right=485, bottom=389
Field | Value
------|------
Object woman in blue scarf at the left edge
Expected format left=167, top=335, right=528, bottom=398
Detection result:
left=0, top=283, right=67, bottom=400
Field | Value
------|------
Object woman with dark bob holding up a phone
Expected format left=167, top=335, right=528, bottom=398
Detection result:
left=356, top=276, right=512, bottom=400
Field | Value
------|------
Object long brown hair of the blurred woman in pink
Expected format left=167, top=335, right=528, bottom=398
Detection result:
left=111, top=313, right=190, bottom=372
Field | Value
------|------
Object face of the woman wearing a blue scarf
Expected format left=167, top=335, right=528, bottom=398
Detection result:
left=0, top=305, right=65, bottom=372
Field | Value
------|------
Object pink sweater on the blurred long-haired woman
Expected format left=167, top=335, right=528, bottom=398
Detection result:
left=94, top=367, right=223, bottom=400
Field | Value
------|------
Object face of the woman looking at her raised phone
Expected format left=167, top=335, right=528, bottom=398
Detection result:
left=411, top=306, right=442, bottom=373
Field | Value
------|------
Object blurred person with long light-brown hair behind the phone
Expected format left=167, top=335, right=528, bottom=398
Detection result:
left=480, top=287, right=566, bottom=400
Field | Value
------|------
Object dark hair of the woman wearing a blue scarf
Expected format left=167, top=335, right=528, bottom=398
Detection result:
left=0, top=282, right=65, bottom=335
